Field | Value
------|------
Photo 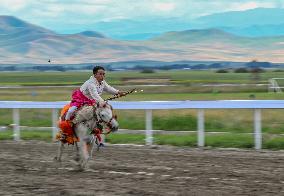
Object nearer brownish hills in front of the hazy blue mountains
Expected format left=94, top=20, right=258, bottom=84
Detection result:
left=0, top=10, right=284, bottom=64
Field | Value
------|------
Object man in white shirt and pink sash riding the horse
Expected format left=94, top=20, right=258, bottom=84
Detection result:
left=61, top=66, right=126, bottom=144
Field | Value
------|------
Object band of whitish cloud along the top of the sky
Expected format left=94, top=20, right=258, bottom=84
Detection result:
left=0, top=0, right=284, bottom=20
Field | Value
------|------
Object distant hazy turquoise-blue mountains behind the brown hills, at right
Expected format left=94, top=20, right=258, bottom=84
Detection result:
left=91, top=8, right=284, bottom=40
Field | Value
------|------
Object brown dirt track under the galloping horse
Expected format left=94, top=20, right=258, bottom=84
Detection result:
left=0, top=141, right=284, bottom=196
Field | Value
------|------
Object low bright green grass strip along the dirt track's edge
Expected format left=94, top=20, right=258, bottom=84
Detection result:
left=0, top=130, right=284, bottom=150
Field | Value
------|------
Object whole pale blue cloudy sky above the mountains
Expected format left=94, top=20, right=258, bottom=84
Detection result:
left=0, top=0, right=284, bottom=33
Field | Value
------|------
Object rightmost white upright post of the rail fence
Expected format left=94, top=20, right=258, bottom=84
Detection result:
left=254, top=109, right=262, bottom=150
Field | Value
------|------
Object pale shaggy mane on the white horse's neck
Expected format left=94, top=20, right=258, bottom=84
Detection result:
left=72, top=106, right=96, bottom=124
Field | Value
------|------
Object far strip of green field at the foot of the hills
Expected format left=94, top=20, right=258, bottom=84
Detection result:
left=0, top=70, right=283, bottom=86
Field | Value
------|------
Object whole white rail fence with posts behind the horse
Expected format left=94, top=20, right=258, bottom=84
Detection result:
left=0, top=100, right=284, bottom=149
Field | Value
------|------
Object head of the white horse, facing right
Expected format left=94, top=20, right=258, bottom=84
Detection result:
left=95, top=103, right=119, bottom=132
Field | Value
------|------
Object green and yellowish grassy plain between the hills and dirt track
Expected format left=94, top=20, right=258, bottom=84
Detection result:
left=0, top=71, right=284, bottom=148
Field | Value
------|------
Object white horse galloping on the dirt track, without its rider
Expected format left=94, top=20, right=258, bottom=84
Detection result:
left=55, top=104, right=118, bottom=169
